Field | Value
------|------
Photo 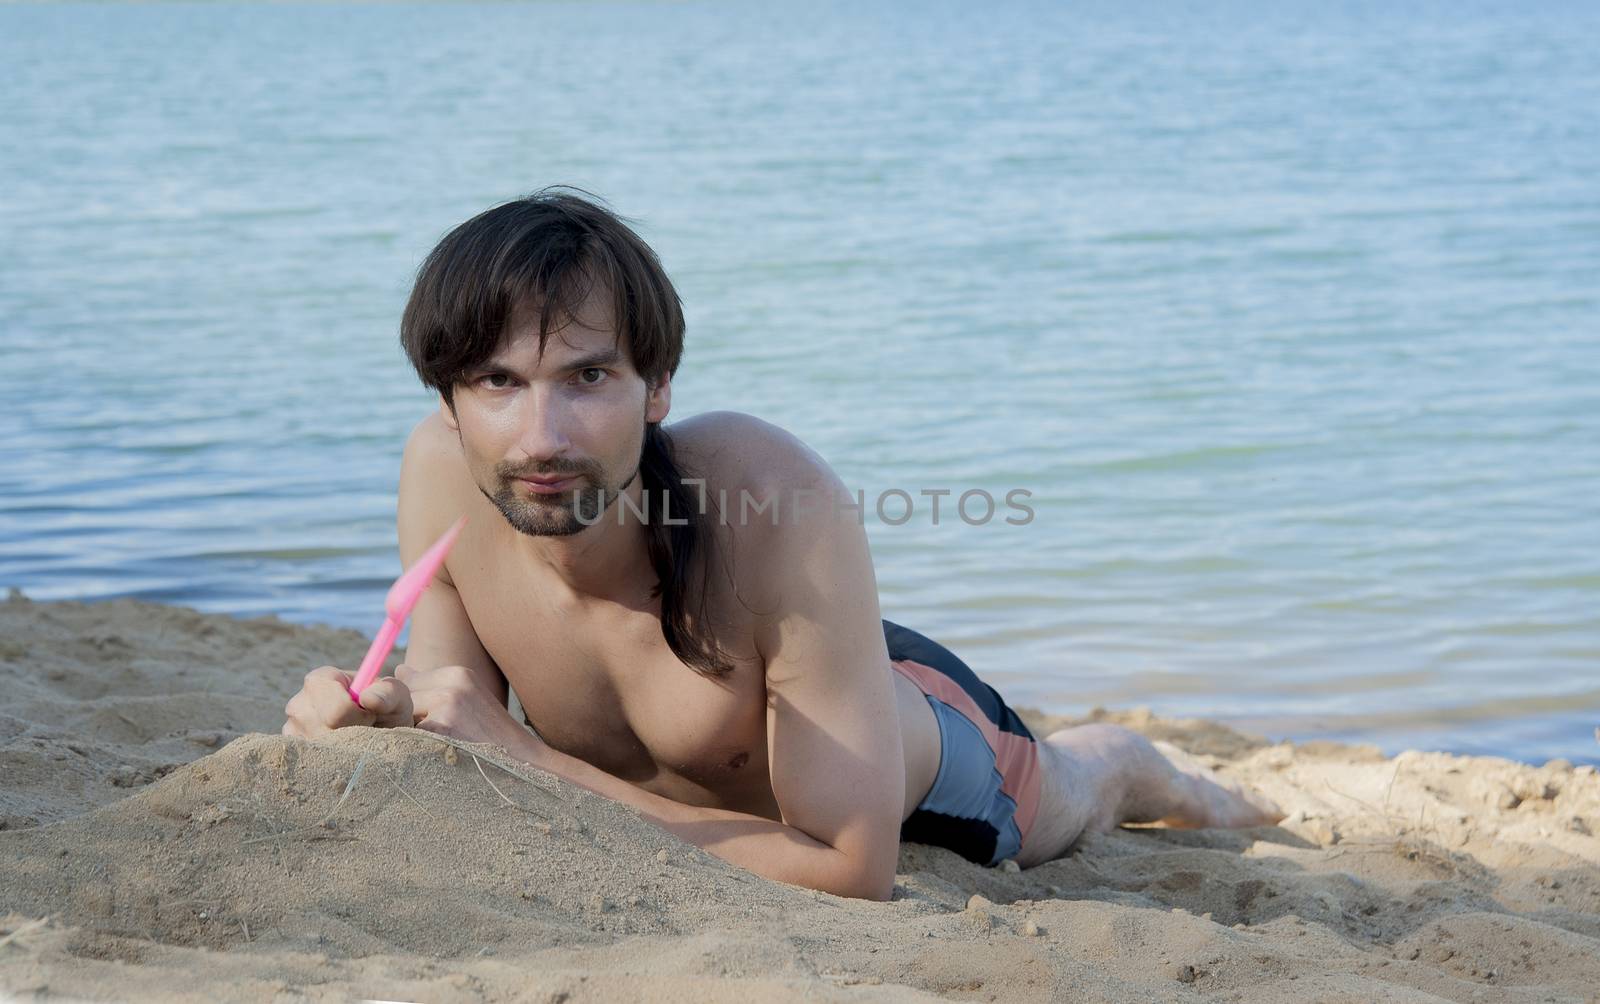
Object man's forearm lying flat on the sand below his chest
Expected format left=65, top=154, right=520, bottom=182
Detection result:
left=496, top=725, right=893, bottom=900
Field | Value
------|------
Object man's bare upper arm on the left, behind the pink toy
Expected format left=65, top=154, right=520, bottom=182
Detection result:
left=395, top=412, right=509, bottom=707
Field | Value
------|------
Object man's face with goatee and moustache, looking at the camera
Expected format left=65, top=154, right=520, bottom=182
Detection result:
left=443, top=288, right=670, bottom=537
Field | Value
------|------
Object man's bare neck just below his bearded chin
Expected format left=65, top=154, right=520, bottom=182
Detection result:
left=506, top=476, right=656, bottom=609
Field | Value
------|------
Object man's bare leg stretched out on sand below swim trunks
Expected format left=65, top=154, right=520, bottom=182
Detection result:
left=1019, top=724, right=1283, bottom=865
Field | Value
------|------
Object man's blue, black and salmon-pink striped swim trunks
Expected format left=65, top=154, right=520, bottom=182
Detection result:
left=883, top=620, right=1040, bottom=865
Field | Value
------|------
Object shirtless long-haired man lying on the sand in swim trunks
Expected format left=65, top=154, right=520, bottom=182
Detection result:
left=283, top=190, right=1280, bottom=900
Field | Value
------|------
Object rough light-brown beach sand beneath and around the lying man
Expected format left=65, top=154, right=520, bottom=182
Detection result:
left=0, top=592, right=1600, bottom=1004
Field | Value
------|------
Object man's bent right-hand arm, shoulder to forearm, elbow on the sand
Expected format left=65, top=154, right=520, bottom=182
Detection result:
left=510, top=450, right=906, bottom=900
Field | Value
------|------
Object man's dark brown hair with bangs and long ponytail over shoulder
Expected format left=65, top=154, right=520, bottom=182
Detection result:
left=400, top=185, right=733, bottom=676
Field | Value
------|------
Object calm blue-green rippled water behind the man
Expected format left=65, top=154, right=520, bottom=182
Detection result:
left=0, top=2, right=1600, bottom=761
